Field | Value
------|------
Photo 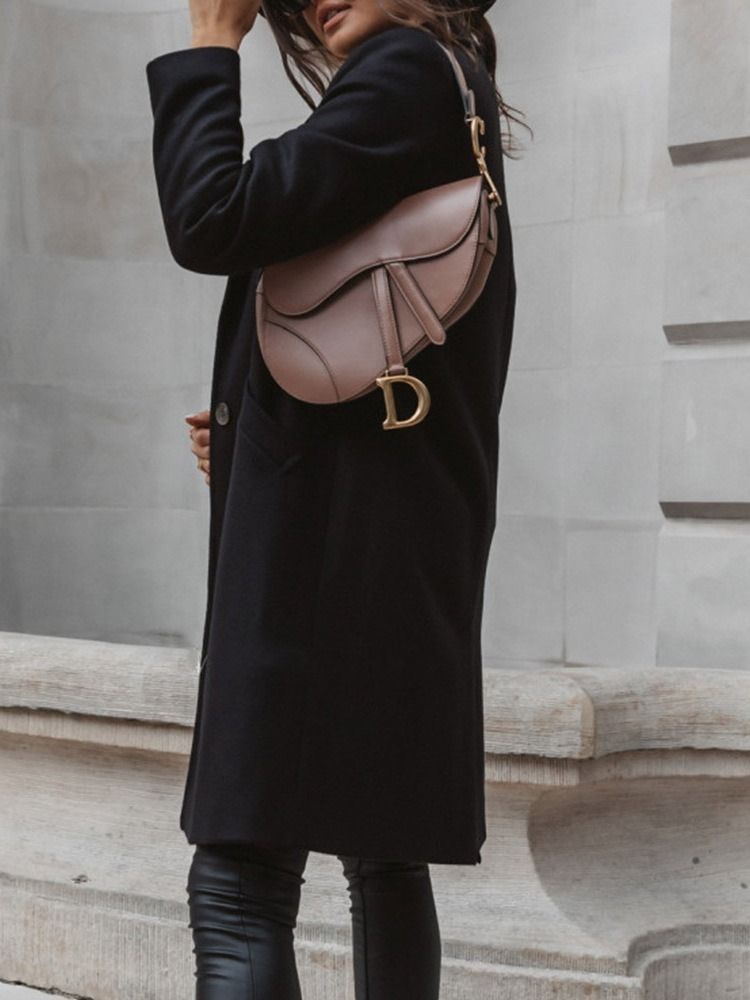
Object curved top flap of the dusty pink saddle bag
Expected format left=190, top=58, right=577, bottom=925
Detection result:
left=262, top=175, right=482, bottom=316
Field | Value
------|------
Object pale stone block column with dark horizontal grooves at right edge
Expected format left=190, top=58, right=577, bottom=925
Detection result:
left=657, top=0, right=750, bottom=669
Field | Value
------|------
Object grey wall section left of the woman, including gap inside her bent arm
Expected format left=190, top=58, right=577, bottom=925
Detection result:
left=0, top=0, right=307, bottom=646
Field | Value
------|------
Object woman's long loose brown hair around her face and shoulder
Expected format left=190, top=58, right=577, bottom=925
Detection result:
left=263, top=0, right=533, bottom=159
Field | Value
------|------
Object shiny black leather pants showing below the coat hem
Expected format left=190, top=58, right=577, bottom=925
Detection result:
left=187, top=844, right=441, bottom=1000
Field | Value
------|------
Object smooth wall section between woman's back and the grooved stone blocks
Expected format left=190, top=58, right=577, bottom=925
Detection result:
left=484, top=0, right=673, bottom=668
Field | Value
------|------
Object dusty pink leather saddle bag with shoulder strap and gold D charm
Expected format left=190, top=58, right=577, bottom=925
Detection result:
left=255, top=39, right=501, bottom=430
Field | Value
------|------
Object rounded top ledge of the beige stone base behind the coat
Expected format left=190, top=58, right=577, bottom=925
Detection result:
left=0, top=632, right=750, bottom=761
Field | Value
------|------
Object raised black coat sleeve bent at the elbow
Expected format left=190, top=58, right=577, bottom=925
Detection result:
left=146, top=25, right=468, bottom=275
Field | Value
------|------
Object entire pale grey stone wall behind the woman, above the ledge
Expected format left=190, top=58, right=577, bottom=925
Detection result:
left=8, top=0, right=750, bottom=669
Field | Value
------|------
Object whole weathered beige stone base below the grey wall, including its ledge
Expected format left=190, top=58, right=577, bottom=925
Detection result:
left=0, top=632, right=750, bottom=1000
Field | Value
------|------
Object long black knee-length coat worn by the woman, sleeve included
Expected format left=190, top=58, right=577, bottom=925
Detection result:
left=147, top=26, right=515, bottom=864
